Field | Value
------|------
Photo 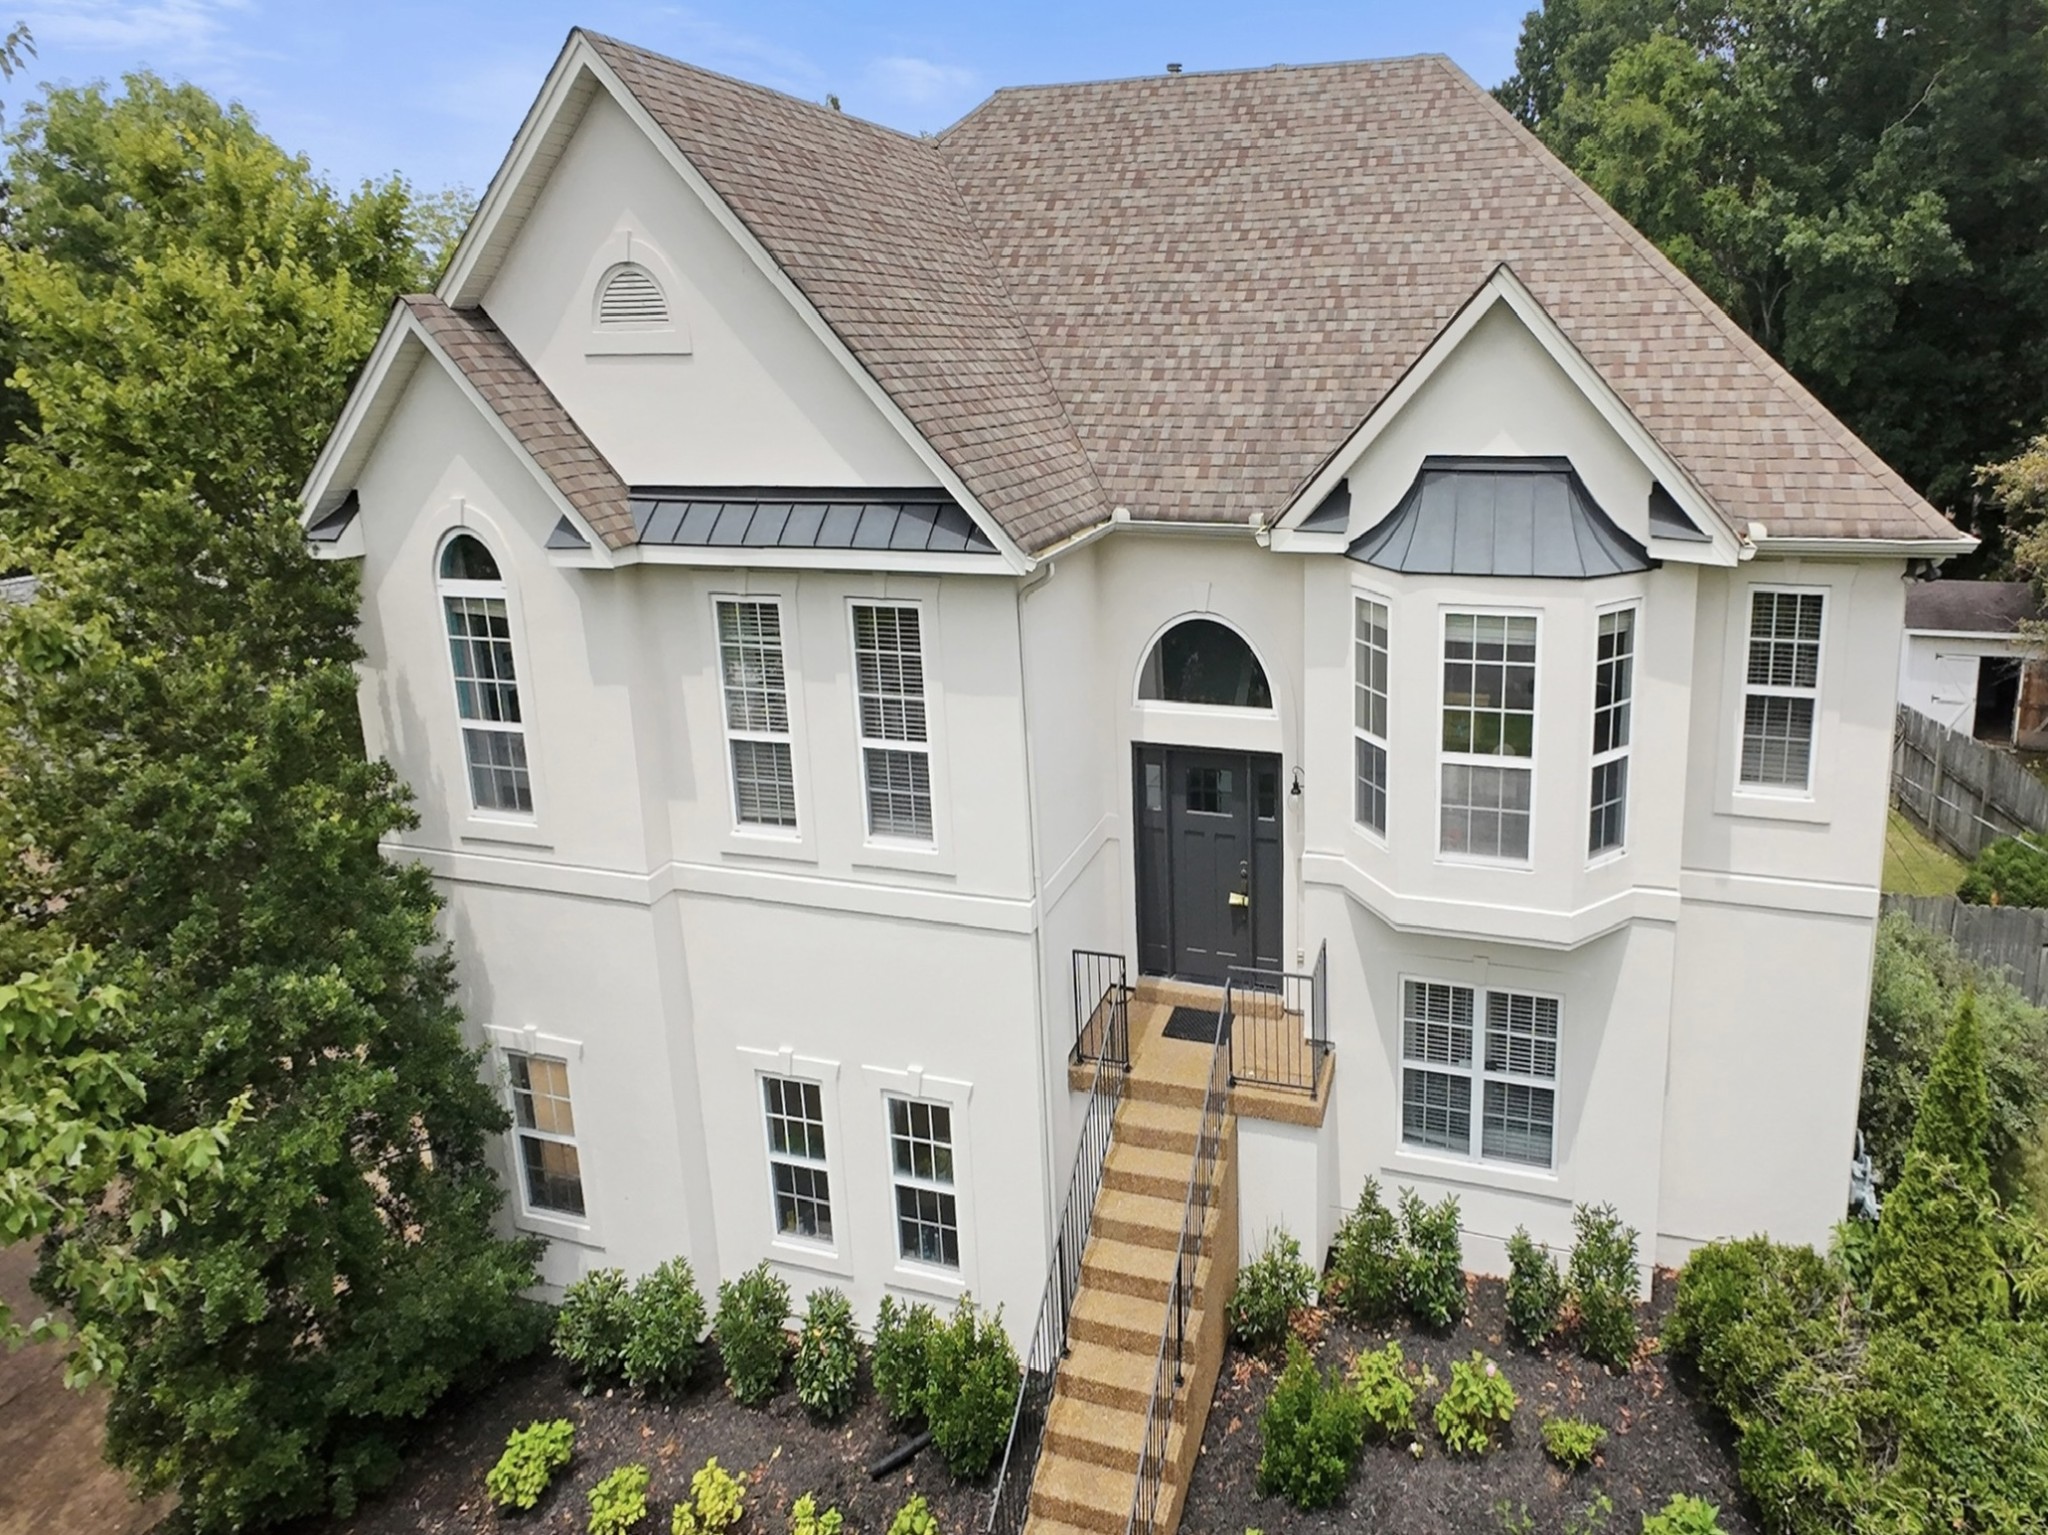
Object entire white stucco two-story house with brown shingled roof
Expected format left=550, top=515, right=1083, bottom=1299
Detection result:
left=305, top=33, right=1972, bottom=1358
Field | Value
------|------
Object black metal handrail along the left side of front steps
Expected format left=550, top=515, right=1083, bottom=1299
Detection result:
left=985, top=950, right=1130, bottom=1535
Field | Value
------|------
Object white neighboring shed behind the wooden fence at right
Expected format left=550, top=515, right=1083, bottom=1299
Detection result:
left=1898, top=581, right=2048, bottom=751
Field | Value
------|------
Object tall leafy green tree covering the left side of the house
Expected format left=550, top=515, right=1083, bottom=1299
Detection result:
left=0, top=76, right=537, bottom=1529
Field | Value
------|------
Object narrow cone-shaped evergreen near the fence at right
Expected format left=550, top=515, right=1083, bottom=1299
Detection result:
left=1870, top=993, right=1999, bottom=1339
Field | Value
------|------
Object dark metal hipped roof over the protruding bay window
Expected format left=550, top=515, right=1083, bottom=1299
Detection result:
left=1346, top=458, right=1651, bottom=581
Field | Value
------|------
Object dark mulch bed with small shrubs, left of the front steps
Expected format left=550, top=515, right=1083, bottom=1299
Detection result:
left=295, top=1349, right=993, bottom=1535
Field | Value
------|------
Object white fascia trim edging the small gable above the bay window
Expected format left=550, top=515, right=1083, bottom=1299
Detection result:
left=1274, top=264, right=1739, bottom=567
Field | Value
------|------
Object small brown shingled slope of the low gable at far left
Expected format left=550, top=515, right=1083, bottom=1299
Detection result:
left=406, top=293, right=633, bottom=549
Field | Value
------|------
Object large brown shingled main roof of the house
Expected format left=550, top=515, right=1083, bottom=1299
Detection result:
left=499, top=35, right=1956, bottom=553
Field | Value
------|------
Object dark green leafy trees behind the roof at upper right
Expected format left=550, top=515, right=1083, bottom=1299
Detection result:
left=1497, top=0, right=2048, bottom=563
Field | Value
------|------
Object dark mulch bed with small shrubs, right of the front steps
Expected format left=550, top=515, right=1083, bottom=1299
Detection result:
left=1182, top=1275, right=1761, bottom=1535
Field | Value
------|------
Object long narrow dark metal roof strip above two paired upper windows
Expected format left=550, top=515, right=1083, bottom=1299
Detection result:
left=631, top=485, right=995, bottom=555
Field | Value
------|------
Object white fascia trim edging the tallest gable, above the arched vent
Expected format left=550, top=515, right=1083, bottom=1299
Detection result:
left=438, top=41, right=1036, bottom=575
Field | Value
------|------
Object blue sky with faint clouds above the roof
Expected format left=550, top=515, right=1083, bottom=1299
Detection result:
left=0, top=0, right=1534, bottom=190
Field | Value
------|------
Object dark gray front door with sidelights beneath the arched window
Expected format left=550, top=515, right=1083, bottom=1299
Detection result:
left=1133, top=747, right=1280, bottom=982
